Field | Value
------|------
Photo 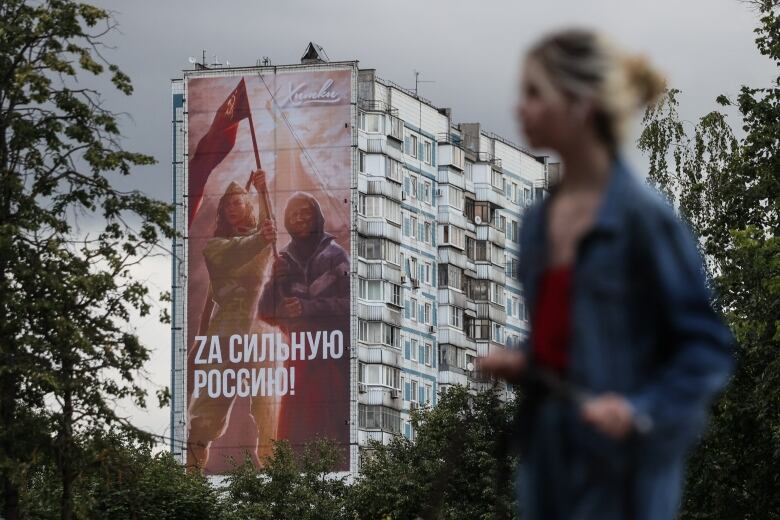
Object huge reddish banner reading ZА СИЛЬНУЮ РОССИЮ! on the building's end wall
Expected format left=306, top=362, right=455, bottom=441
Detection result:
left=186, top=69, right=353, bottom=474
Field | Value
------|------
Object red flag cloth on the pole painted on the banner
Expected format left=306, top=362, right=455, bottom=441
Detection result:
left=189, top=78, right=249, bottom=224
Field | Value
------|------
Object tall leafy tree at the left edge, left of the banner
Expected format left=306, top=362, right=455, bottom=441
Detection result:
left=0, top=0, right=174, bottom=519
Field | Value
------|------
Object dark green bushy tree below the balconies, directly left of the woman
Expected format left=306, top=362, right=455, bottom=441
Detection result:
left=350, top=386, right=516, bottom=519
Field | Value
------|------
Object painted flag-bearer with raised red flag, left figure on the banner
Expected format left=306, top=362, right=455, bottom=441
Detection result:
left=188, top=79, right=278, bottom=469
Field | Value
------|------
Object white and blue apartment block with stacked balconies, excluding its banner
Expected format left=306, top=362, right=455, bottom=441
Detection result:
left=171, top=53, right=550, bottom=472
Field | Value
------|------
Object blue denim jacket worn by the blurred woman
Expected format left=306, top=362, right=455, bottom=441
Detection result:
left=518, top=153, right=734, bottom=459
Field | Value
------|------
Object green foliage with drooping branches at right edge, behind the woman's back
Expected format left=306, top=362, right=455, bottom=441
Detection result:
left=639, top=0, right=780, bottom=519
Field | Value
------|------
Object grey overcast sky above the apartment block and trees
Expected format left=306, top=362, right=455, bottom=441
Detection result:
left=95, top=0, right=776, bottom=442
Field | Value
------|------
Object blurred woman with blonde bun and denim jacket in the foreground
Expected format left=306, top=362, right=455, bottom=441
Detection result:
left=480, top=30, right=733, bottom=520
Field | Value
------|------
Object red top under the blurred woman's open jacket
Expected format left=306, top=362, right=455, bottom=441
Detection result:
left=531, top=265, right=571, bottom=373
